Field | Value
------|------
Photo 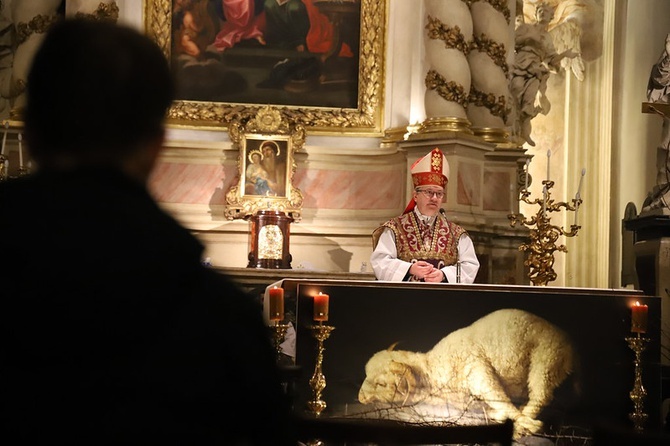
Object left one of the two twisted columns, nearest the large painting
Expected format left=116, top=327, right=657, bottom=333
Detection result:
left=419, top=0, right=472, bottom=133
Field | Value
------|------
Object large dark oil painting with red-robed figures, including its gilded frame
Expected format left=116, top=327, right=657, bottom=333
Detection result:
left=146, top=0, right=387, bottom=134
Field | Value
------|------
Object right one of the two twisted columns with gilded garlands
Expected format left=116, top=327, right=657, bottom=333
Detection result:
left=467, top=0, right=514, bottom=142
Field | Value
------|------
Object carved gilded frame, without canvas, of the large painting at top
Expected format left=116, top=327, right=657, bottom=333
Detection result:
left=145, top=0, right=389, bottom=135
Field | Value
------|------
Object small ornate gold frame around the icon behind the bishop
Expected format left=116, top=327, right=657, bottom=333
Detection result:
left=224, top=106, right=305, bottom=222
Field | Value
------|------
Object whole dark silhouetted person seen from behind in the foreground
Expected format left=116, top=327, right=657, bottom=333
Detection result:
left=0, top=18, right=296, bottom=445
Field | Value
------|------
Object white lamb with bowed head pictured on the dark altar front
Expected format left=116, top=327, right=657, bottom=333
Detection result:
left=358, top=309, right=578, bottom=438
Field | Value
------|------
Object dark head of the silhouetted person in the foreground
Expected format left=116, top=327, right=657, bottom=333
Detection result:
left=24, top=18, right=175, bottom=178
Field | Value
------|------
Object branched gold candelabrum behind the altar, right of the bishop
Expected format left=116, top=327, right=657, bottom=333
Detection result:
left=507, top=179, right=583, bottom=286
